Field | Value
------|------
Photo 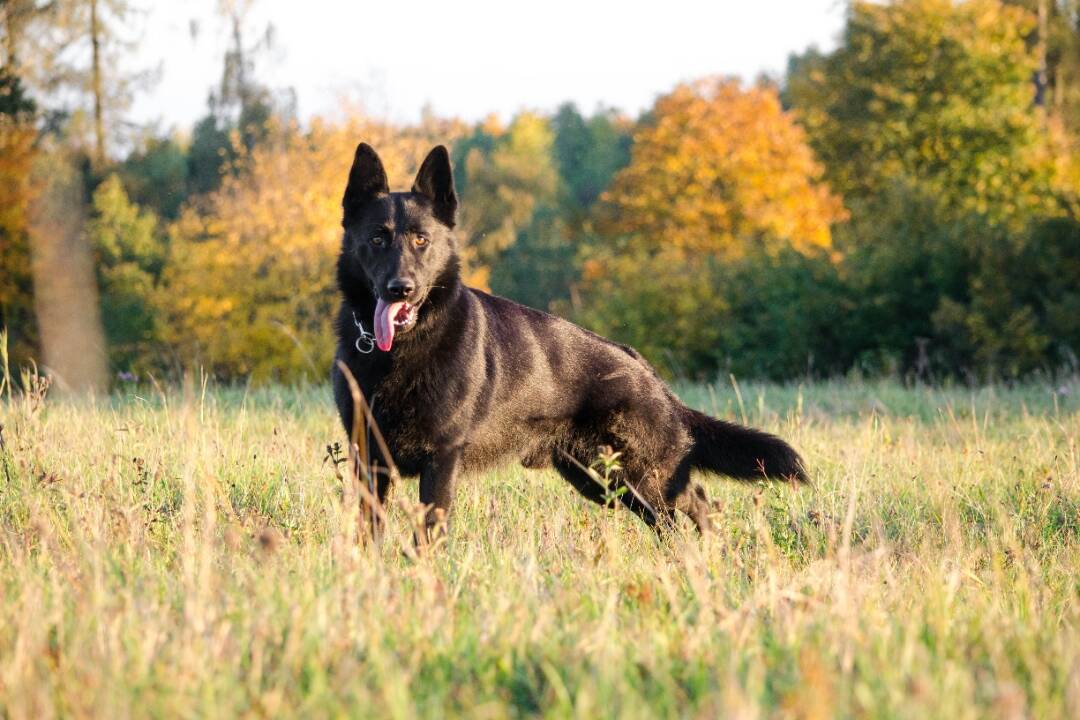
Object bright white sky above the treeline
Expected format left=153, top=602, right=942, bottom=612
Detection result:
left=133, top=0, right=847, bottom=130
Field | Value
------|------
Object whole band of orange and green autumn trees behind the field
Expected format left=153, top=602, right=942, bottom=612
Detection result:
left=0, top=0, right=1080, bottom=388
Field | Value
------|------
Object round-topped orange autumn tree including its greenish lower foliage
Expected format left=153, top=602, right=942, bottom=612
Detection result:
left=578, top=80, right=843, bottom=375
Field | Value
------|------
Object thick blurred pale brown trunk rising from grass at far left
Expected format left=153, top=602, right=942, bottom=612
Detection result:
left=27, top=152, right=108, bottom=393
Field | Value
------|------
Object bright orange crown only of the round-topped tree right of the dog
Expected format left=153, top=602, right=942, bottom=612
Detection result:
left=597, top=79, right=845, bottom=258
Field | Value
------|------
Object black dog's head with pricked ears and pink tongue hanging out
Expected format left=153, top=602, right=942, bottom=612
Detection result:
left=339, top=142, right=459, bottom=351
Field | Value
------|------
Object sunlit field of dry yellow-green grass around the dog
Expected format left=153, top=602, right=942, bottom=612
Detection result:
left=0, top=381, right=1080, bottom=720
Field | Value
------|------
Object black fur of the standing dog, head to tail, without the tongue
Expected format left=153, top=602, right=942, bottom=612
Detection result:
left=333, top=144, right=806, bottom=531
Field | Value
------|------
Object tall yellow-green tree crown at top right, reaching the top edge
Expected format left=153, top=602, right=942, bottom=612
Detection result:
left=785, top=0, right=1056, bottom=221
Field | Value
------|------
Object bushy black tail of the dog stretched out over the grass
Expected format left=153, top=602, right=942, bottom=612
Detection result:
left=685, top=408, right=810, bottom=483
